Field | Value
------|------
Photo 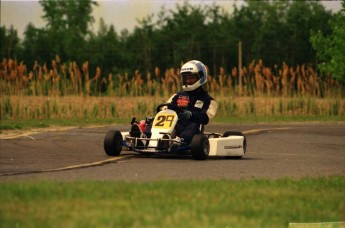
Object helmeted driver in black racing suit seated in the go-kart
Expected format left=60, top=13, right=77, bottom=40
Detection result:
left=131, top=60, right=217, bottom=144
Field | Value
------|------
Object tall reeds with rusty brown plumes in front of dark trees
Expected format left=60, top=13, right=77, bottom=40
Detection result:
left=0, top=56, right=344, bottom=98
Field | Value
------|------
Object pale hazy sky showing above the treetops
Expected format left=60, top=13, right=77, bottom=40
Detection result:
left=0, top=0, right=341, bottom=38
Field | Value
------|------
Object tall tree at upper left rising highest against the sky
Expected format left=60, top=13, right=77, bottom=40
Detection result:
left=39, top=0, right=97, bottom=61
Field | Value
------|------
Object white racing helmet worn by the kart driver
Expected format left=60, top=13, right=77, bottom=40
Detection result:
left=180, top=60, right=207, bottom=91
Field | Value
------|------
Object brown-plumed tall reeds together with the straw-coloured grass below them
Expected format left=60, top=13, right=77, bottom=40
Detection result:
left=0, top=56, right=345, bottom=120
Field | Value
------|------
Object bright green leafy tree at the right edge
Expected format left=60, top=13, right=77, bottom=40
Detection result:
left=311, top=1, right=345, bottom=82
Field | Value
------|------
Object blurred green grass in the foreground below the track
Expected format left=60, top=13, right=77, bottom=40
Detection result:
left=0, top=177, right=345, bottom=227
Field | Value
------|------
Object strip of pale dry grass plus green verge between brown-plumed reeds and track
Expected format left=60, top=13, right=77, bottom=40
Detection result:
left=0, top=96, right=345, bottom=130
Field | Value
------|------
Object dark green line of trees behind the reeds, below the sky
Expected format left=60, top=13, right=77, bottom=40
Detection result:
left=0, top=0, right=345, bottom=81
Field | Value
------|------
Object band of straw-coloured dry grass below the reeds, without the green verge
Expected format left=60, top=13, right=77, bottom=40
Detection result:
left=0, top=96, right=345, bottom=120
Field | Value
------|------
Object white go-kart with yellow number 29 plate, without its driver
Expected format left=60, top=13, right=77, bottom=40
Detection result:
left=104, top=103, right=247, bottom=160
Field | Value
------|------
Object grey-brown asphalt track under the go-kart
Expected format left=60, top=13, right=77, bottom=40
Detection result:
left=0, top=122, right=345, bottom=182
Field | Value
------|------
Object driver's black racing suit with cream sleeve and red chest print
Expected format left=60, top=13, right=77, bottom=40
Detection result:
left=167, top=87, right=217, bottom=143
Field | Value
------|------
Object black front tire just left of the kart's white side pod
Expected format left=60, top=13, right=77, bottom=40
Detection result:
left=190, top=134, right=210, bottom=160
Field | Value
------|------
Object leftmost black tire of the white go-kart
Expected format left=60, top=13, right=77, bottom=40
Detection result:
left=104, top=130, right=123, bottom=156
